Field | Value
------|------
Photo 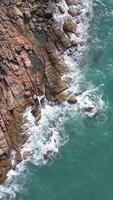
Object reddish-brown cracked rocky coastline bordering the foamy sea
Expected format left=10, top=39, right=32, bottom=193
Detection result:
left=0, top=0, right=83, bottom=183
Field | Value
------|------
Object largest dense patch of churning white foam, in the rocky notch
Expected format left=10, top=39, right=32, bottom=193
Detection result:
left=21, top=104, right=67, bottom=165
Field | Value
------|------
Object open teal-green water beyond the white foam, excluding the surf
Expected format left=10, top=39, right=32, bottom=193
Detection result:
left=16, top=0, right=113, bottom=200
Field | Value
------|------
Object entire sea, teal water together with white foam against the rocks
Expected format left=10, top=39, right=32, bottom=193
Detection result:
left=0, top=0, right=113, bottom=200
